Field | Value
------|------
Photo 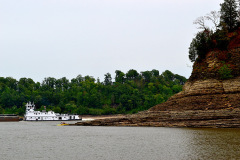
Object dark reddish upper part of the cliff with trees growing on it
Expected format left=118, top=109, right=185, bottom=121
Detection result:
left=189, top=0, right=240, bottom=81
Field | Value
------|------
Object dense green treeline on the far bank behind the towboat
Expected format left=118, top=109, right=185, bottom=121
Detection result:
left=0, top=69, right=186, bottom=115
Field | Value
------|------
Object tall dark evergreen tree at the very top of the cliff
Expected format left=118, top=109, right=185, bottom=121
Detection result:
left=220, top=0, right=239, bottom=31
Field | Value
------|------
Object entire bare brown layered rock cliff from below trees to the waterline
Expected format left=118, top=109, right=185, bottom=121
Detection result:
left=76, top=48, right=240, bottom=128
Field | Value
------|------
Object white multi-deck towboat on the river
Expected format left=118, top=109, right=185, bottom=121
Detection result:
left=24, top=102, right=81, bottom=121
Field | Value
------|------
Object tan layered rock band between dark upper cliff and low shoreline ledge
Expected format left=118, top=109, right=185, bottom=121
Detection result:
left=149, top=77, right=240, bottom=111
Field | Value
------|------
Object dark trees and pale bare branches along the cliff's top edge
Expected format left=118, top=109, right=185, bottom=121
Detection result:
left=189, top=0, right=240, bottom=62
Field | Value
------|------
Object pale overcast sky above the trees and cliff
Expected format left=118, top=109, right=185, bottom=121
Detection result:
left=0, top=0, right=223, bottom=82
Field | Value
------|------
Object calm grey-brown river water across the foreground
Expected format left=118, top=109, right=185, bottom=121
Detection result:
left=0, top=121, right=240, bottom=160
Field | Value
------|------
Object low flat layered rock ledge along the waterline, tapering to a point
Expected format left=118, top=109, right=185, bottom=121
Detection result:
left=74, top=109, right=240, bottom=128
